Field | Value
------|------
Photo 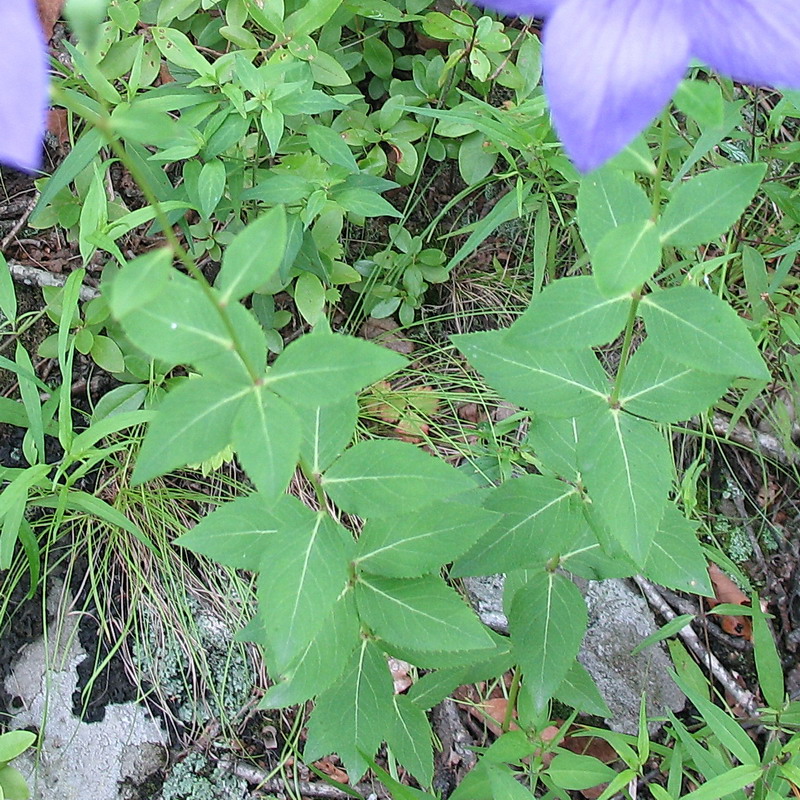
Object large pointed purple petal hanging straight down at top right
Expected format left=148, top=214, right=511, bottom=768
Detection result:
left=543, top=0, right=700, bottom=172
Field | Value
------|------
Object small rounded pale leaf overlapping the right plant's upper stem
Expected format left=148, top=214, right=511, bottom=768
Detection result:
left=592, top=219, right=661, bottom=298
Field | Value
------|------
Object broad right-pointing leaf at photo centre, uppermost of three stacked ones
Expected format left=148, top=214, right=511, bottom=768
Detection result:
left=322, top=439, right=475, bottom=517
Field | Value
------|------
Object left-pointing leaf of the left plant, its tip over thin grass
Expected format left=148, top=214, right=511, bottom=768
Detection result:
left=175, top=494, right=317, bottom=572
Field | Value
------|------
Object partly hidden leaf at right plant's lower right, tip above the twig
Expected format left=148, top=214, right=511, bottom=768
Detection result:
left=643, top=505, right=714, bottom=597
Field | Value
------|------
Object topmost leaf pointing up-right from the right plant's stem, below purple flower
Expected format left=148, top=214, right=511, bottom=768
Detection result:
left=658, top=164, right=767, bottom=247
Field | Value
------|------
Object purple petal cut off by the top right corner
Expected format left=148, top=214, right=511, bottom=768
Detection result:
left=684, top=0, right=800, bottom=89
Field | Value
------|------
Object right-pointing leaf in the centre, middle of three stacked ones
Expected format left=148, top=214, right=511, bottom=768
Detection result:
left=355, top=499, right=498, bottom=578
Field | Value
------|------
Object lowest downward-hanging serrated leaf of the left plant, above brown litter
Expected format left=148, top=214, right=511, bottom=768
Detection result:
left=303, top=641, right=394, bottom=783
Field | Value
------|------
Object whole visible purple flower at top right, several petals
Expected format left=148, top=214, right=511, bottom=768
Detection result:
left=479, top=0, right=800, bottom=172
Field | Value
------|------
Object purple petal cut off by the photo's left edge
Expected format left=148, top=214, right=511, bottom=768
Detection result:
left=0, top=0, right=48, bottom=171
